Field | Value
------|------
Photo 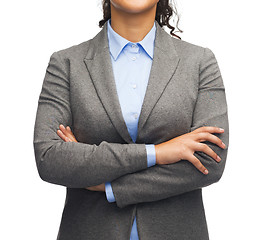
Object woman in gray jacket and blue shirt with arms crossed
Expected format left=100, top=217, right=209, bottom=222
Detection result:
left=34, top=0, right=229, bottom=240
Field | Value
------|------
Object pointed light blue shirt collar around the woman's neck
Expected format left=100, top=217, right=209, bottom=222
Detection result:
left=107, top=18, right=156, bottom=60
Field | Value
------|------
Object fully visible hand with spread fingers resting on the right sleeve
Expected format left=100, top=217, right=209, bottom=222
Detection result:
left=155, top=126, right=225, bottom=174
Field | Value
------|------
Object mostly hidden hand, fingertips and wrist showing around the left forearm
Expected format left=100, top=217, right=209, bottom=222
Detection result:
left=57, top=124, right=105, bottom=192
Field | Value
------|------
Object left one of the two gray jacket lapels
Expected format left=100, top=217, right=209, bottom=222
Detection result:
left=84, top=22, right=133, bottom=143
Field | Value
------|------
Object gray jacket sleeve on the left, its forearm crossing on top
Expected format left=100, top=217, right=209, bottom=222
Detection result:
left=33, top=52, right=147, bottom=188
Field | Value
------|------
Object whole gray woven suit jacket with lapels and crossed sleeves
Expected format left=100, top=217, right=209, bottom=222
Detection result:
left=33, top=19, right=229, bottom=240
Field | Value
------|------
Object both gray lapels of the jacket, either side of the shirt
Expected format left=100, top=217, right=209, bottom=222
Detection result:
left=84, top=21, right=180, bottom=143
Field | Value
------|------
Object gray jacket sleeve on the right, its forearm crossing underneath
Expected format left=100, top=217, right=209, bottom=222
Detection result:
left=108, top=48, right=229, bottom=208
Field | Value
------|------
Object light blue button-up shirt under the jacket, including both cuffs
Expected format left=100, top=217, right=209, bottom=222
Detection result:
left=105, top=19, right=156, bottom=240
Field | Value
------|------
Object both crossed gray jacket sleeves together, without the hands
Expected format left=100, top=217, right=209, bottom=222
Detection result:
left=34, top=48, right=229, bottom=208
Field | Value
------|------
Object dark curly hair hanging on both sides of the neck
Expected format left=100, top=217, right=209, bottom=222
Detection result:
left=99, top=0, right=183, bottom=39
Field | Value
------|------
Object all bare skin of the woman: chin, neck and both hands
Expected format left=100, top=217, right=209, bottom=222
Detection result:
left=57, top=0, right=225, bottom=191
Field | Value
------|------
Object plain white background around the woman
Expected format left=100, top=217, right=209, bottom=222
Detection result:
left=0, top=0, right=268, bottom=240
